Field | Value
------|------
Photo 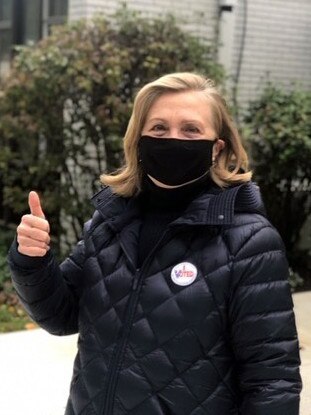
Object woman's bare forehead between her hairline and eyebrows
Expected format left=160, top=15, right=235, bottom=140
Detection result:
left=147, top=91, right=211, bottom=122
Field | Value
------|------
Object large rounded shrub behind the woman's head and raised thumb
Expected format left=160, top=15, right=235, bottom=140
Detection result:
left=0, top=9, right=223, bottom=254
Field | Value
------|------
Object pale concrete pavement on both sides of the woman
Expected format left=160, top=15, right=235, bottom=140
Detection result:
left=0, top=291, right=311, bottom=415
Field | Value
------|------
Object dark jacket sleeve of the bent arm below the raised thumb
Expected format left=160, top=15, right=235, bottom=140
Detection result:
left=8, top=229, right=88, bottom=335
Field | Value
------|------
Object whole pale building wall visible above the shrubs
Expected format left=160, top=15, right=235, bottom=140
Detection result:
left=69, top=0, right=311, bottom=107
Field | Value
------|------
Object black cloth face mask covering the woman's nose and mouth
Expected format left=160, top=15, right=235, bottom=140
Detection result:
left=138, top=136, right=217, bottom=186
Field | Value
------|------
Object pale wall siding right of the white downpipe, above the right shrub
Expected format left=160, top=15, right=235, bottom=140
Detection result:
left=231, top=0, right=311, bottom=106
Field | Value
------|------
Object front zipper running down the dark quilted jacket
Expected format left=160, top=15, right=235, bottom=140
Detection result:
left=100, top=232, right=171, bottom=415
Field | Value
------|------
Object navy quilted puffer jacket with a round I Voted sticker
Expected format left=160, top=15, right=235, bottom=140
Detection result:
left=9, top=183, right=301, bottom=415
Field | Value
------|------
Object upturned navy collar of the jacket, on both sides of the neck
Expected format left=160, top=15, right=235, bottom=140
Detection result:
left=91, top=182, right=265, bottom=229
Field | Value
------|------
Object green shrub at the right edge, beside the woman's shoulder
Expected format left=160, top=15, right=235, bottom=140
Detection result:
left=245, top=84, right=311, bottom=274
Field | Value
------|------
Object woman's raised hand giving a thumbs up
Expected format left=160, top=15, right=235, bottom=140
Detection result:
left=17, top=192, right=50, bottom=257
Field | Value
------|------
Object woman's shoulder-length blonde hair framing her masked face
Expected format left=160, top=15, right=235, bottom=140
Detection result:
left=101, top=72, right=252, bottom=197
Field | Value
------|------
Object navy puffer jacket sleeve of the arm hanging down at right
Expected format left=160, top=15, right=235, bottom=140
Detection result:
left=229, top=219, right=301, bottom=415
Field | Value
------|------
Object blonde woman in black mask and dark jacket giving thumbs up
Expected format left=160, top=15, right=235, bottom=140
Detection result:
left=9, top=73, right=301, bottom=415
